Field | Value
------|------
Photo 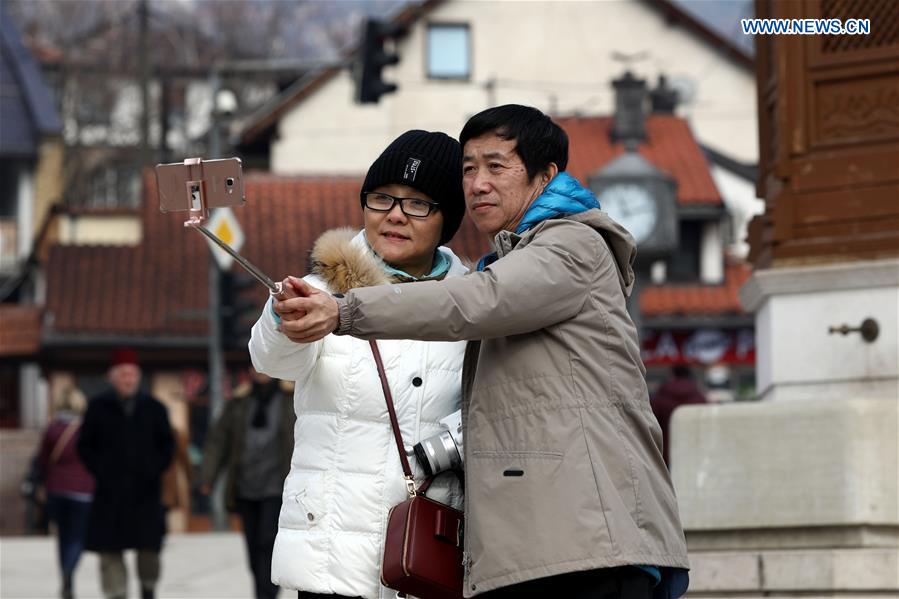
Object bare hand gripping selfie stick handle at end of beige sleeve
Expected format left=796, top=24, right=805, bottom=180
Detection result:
left=273, top=277, right=339, bottom=343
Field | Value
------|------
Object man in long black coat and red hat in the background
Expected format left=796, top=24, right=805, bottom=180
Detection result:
left=78, top=349, right=174, bottom=599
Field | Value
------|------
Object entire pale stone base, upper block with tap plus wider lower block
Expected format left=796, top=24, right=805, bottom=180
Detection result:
left=670, top=260, right=899, bottom=597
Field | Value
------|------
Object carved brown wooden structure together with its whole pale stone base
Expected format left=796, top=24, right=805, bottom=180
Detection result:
left=670, top=0, right=899, bottom=598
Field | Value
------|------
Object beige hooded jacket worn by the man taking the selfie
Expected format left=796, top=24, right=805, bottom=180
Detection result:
left=338, top=210, right=689, bottom=597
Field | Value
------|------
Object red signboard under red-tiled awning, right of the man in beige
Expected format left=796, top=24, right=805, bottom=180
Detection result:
left=641, top=328, right=755, bottom=366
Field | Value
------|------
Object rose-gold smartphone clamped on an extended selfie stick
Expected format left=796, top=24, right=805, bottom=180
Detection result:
left=155, top=158, right=281, bottom=295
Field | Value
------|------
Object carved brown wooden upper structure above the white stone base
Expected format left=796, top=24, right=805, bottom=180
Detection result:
left=749, top=0, right=899, bottom=268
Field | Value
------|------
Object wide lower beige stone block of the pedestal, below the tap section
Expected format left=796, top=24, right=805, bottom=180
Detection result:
left=671, top=399, right=899, bottom=597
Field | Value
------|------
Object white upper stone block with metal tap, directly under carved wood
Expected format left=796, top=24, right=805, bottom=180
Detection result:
left=740, top=259, right=899, bottom=401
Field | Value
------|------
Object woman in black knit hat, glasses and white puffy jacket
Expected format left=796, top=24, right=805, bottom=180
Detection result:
left=250, top=131, right=467, bottom=599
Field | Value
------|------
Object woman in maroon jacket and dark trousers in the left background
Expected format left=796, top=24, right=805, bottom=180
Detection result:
left=39, top=387, right=94, bottom=599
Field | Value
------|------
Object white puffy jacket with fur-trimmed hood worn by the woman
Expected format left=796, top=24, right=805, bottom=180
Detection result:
left=250, top=230, right=467, bottom=599
